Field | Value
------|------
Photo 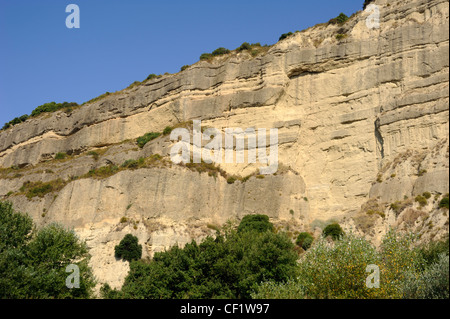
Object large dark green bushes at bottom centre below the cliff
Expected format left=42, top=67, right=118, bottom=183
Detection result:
left=102, top=221, right=298, bottom=299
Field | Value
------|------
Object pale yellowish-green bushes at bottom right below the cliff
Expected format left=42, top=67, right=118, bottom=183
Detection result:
left=252, top=230, right=449, bottom=299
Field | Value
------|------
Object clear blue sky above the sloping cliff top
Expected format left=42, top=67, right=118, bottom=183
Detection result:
left=0, top=0, right=364, bottom=128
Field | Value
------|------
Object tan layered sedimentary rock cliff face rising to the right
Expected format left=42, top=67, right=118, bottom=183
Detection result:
left=0, top=0, right=449, bottom=287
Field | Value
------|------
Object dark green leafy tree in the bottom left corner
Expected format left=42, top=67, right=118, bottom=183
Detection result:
left=0, top=202, right=95, bottom=299
